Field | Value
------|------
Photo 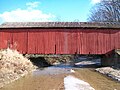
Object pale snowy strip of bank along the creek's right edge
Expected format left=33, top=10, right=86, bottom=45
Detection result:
left=96, top=67, right=120, bottom=81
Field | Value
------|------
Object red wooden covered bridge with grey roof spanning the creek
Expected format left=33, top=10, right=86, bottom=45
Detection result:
left=0, top=22, right=120, bottom=54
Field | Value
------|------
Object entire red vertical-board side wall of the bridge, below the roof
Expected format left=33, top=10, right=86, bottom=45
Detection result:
left=0, top=29, right=120, bottom=54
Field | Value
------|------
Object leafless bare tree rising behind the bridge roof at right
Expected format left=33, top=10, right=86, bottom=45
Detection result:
left=88, top=0, right=120, bottom=22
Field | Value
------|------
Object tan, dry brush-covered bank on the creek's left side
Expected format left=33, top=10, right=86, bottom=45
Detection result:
left=0, top=48, right=35, bottom=88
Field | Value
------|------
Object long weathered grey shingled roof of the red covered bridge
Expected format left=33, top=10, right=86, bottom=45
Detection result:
left=0, top=22, right=120, bottom=28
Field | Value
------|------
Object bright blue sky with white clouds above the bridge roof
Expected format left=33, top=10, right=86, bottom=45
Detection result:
left=0, top=0, right=101, bottom=23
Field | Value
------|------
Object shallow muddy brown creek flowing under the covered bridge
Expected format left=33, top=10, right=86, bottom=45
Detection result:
left=0, top=56, right=120, bottom=90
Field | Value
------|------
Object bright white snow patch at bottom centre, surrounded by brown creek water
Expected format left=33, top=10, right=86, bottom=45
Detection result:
left=64, top=75, right=95, bottom=90
